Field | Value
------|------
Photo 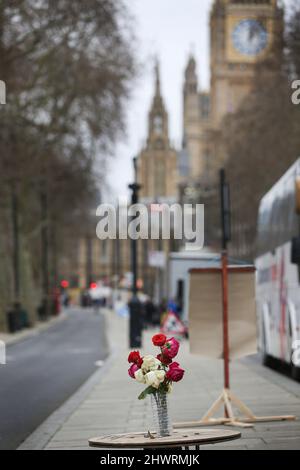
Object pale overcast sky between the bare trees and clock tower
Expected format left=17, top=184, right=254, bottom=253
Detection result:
left=109, top=0, right=291, bottom=197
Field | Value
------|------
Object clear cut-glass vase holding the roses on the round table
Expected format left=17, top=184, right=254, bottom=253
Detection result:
left=151, top=392, right=172, bottom=437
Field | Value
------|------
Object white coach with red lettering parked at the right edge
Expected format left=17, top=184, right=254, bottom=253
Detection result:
left=255, top=159, right=300, bottom=379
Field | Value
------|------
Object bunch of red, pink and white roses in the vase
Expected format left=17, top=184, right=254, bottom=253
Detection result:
left=128, top=334, right=184, bottom=400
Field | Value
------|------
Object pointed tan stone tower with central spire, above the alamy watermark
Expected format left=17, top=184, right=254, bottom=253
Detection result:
left=138, top=64, right=178, bottom=202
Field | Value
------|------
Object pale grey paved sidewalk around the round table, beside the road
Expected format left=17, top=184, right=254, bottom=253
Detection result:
left=25, top=312, right=300, bottom=450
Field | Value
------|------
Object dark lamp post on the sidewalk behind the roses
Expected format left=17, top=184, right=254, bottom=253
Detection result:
left=128, top=157, right=142, bottom=348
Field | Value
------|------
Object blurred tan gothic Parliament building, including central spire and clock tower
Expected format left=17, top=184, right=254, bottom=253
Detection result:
left=73, top=0, right=283, bottom=292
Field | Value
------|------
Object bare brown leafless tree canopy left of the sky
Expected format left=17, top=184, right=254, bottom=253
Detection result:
left=0, top=0, right=136, bottom=328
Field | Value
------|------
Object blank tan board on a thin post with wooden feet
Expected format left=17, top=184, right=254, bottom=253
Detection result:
left=189, top=267, right=257, bottom=359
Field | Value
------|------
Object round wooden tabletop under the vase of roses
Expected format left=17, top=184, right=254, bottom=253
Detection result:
left=89, top=428, right=241, bottom=448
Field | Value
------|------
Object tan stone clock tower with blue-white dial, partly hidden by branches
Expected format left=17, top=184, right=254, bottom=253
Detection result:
left=210, top=0, right=283, bottom=128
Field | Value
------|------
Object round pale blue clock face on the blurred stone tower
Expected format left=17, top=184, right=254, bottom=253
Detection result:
left=232, top=19, right=268, bottom=56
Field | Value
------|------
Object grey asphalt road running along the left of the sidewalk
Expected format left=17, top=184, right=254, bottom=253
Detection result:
left=0, top=309, right=108, bottom=450
